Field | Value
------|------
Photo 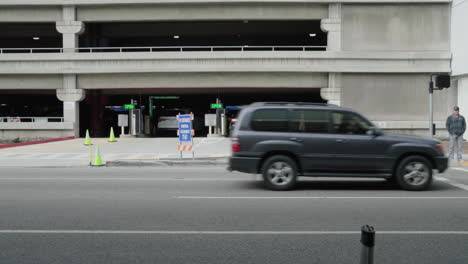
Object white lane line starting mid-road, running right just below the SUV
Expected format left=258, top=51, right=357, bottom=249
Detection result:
left=174, top=196, right=468, bottom=200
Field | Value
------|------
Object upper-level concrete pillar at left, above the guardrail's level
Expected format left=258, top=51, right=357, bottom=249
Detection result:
left=55, top=6, right=84, bottom=53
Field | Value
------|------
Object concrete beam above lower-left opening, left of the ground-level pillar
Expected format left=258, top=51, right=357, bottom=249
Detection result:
left=0, top=74, right=63, bottom=90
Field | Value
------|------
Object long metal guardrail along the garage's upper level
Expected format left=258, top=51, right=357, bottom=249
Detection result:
left=0, top=45, right=327, bottom=54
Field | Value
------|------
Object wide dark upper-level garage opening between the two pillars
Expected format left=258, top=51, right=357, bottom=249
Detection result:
left=80, top=20, right=327, bottom=49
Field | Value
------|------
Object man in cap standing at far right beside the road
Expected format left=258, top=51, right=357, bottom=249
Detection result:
left=445, top=106, right=466, bottom=161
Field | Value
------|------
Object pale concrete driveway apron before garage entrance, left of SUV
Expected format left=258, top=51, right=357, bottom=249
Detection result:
left=0, top=138, right=230, bottom=167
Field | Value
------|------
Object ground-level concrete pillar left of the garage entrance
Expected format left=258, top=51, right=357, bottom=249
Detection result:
left=57, top=74, right=86, bottom=137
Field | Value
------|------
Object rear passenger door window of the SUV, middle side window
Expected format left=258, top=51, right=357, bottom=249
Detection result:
left=290, top=109, right=329, bottom=133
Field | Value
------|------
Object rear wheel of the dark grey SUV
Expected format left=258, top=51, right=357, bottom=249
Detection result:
left=261, top=155, right=297, bottom=191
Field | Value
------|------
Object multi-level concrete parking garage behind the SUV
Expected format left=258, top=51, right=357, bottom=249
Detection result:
left=0, top=0, right=456, bottom=138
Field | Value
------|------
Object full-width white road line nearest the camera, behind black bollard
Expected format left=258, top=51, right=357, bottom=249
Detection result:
left=0, top=229, right=468, bottom=235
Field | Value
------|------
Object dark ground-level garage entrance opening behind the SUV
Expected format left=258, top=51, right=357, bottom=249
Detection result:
left=80, top=88, right=326, bottom=137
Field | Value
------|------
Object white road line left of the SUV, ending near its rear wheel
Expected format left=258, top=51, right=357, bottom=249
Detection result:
left=0, top=177, right=250, bottom=181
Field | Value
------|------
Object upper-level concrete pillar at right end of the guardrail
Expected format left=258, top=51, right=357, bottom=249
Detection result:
left=320, top=3, right=341, bottom=51
